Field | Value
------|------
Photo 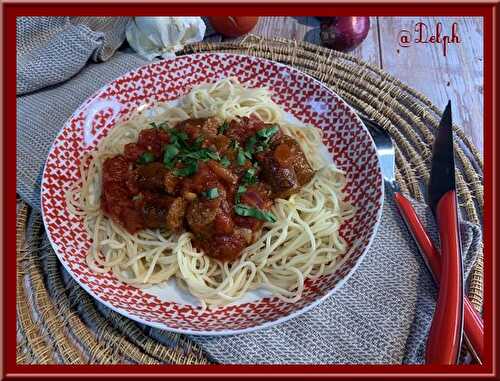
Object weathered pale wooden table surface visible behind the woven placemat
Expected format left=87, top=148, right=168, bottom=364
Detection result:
left=207, top=17, right=483, bottom=154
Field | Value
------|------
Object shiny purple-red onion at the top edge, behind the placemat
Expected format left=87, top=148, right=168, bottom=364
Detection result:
left=320, top=16, right=370, bottom=52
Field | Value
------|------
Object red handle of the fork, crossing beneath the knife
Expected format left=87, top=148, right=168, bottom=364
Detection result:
left=394, top=192, right=484, bottom=363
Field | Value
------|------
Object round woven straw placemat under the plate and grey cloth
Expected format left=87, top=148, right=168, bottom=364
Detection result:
left=17, top=35, right=483, bottom=364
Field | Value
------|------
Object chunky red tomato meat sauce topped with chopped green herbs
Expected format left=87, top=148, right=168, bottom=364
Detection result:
left=101, top=117, right=314, bottom=261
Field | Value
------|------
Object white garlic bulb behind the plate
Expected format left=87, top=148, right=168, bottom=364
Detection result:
left=126, top=17, right=206, bottom=61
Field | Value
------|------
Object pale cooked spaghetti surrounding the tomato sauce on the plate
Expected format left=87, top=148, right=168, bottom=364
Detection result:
left=67, top=78, right=354, bottom=308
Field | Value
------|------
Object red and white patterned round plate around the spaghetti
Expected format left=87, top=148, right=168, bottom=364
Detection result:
left=41, top=53, right=383, bottom=335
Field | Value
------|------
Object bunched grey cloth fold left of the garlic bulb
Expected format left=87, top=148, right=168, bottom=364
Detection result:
left=16, top=16, right=129, bottom=95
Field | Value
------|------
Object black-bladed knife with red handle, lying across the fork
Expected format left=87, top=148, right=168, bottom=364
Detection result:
left=425, top=102, right=464, bottom=365
